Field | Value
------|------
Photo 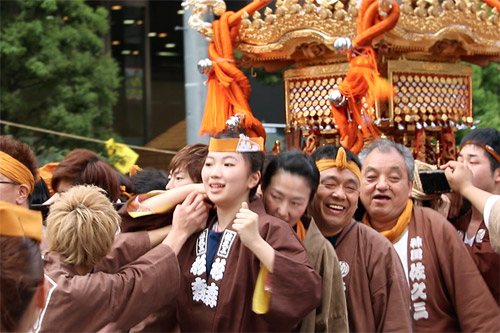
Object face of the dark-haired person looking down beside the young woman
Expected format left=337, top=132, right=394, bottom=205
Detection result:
left=264, top=170, right=311, bottom=227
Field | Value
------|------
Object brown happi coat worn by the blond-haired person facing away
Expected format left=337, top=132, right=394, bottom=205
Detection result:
left=34, top=232, right=180, bottom=332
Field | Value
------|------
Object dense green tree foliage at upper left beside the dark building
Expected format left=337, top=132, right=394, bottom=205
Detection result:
left=0, top=0, right=120, bottom=161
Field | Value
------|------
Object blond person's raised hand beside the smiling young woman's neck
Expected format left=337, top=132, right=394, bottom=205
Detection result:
left=164, top=192, right=208, bottom=252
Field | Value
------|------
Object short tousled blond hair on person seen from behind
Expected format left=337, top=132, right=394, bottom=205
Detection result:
left=47, top=185, right=120, bottom=268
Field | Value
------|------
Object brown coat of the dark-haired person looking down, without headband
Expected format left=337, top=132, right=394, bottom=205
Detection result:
left=300, top=219, right=349, bottom=332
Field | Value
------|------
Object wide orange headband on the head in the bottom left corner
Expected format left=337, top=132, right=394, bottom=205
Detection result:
left=0, top=201, right=42, bottom=242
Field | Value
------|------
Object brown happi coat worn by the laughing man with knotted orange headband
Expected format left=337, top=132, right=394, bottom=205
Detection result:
left=328, top=219, right=411, bottom=332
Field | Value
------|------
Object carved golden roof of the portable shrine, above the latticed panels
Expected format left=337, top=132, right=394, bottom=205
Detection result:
left=185, top=0, right=500, bottom=71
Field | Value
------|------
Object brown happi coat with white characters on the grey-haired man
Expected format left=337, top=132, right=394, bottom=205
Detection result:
left=408, top=206, right=500, bottom=332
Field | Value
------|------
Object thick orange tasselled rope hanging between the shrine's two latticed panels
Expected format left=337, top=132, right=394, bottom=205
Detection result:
left=332, top=0, right=400, bottom=154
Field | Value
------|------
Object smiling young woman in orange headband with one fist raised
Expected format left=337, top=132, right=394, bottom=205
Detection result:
left=174, top=128, right=321, bottom=332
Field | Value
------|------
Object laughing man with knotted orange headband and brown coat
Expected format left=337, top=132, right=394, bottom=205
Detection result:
left=309, top=145, right=412, bottom=332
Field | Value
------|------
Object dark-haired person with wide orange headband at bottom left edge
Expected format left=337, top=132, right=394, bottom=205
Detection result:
left=0, top=202, right=45, bottom=332
